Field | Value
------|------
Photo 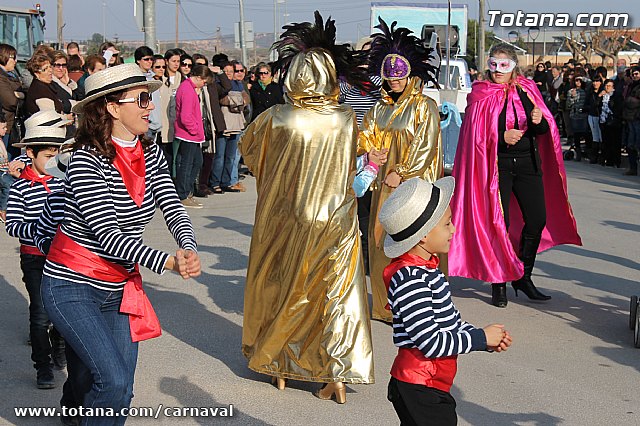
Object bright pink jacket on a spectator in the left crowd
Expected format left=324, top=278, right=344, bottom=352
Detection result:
left=174, top=78, right=204, bottom=143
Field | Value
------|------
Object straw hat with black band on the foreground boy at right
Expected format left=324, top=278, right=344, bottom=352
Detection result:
left=378, top=177, right=456, bottom=259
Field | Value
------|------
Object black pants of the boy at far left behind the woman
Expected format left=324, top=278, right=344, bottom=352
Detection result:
left=20, top=254, right=62, bottom=369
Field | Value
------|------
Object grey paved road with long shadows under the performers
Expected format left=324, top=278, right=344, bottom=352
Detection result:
left=0, top=162, right=640, bottom=425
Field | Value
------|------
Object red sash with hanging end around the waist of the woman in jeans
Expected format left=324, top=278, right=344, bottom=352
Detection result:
left=47, top=228, right=162, bottom=342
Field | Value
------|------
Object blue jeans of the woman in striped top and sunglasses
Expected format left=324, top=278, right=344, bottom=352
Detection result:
left=42, top=275, right=138, bottom=426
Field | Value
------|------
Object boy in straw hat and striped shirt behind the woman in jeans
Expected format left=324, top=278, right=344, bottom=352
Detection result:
left=6, top=124, right=66, bottom=389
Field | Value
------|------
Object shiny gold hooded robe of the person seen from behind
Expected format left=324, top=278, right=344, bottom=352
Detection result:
left=240, top=49, right=374, bottom=383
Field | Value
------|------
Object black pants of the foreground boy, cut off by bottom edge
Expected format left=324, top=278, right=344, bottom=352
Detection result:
left=387, top=377, right=458, bottom=426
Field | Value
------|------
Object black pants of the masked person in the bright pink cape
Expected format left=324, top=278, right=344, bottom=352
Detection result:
left=498, top=152, right=547, bottom=237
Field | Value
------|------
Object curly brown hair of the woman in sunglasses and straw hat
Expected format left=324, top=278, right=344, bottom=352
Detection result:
left=72, top=89, right=153, bottom=163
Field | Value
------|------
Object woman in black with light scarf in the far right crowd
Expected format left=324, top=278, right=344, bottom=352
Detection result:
left=598, top=79, right=622, bottom=167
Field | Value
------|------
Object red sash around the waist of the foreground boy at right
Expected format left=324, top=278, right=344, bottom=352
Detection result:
left=391, top=348, right=458, bottom=392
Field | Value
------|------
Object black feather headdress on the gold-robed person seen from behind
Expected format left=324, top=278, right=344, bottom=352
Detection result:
left=272, top=10, right=369, bottom=90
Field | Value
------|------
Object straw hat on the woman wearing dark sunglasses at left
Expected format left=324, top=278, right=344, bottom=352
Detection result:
left=71, top=64, right=162, bottom=113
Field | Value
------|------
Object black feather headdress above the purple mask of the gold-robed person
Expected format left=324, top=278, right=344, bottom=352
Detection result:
left=369, top=17, right=440, bottom=87
